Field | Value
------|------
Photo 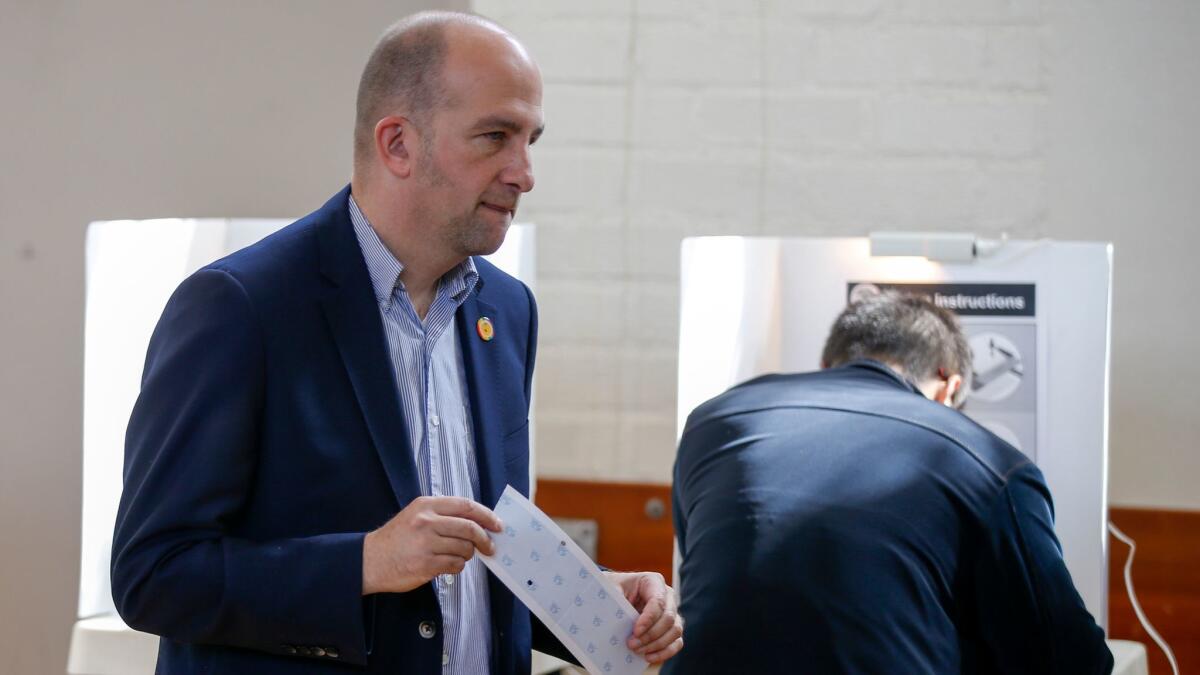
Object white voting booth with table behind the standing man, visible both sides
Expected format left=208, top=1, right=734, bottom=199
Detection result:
left=67, top=219, right=536, bottom=675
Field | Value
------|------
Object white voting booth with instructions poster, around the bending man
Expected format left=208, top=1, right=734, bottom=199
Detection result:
left=678, top=237, right=1112, bottom=626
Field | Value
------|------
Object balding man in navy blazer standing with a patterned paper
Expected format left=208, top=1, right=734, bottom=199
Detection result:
left=112, top=13, right=682, bottom=675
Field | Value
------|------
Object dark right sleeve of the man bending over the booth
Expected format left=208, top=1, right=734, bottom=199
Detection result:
left=973, top=464, right=1112, bottom=675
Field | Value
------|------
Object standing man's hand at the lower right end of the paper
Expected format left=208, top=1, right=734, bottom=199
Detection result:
left=605, top=572, right=683, bottom=663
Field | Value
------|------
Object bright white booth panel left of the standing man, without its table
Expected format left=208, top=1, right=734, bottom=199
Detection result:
left=79, top=219, right=288, bottom=617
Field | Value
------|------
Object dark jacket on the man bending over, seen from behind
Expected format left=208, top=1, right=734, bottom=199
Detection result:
left=664, top=362, right=1112, bottom=675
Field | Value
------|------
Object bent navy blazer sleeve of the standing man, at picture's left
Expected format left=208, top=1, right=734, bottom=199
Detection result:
left=112, top=268, right=366, bottom=664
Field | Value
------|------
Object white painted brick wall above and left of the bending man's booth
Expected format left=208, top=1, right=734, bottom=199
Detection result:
left=474, top=0, right=1050, bottom=482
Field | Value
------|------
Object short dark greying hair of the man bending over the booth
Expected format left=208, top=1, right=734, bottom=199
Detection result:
left=821, top=291, right=972, bottom=407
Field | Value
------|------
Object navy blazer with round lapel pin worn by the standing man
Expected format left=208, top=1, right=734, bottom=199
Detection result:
left=112, top=187, right=553, bottom=674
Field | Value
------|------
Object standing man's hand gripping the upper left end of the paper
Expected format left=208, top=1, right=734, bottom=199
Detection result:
left=362, top=497, right=502, bottom=596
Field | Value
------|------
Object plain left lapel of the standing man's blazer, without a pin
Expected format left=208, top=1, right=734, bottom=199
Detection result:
left=319, top=191, right=421, bottom=508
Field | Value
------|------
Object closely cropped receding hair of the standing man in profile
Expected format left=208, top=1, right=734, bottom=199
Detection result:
left=354, top=11, right=502, bottom=165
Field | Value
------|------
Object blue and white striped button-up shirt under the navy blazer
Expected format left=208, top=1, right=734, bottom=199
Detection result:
left=349, top=197, right=492, bottom=675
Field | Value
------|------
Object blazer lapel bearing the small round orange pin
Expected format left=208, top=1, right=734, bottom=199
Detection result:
left=455, top=285, right=505, bottom=508
